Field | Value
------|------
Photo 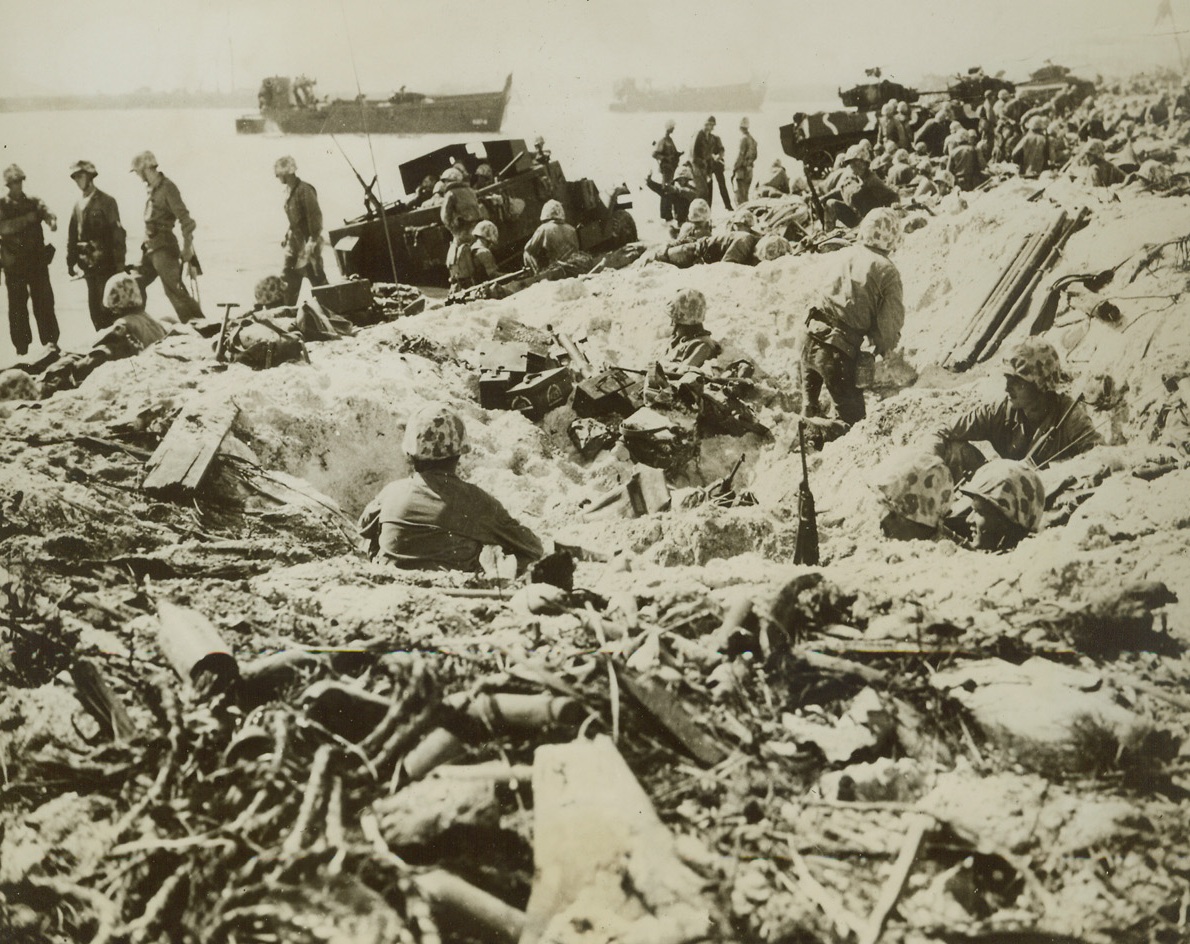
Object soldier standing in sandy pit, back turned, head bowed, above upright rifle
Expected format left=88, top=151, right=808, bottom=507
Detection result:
left=801, top=208, right=904, bottom=427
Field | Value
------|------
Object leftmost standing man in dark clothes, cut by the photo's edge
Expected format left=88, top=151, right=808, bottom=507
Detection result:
left=0, top=164, right=60, bottom=357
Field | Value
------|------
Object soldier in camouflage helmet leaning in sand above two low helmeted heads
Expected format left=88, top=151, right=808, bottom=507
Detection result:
left=934, top=337, right=1102, bottom=481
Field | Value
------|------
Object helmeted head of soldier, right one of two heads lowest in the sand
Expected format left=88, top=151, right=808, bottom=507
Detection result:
left=959, top=458, right=1045, bottom=551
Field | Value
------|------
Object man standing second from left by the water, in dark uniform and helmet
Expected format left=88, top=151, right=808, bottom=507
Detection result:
left=67, top=161, right=126, bottom=331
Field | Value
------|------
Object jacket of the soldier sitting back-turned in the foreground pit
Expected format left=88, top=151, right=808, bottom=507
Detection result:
left=359, top=469, right=543, bottom=573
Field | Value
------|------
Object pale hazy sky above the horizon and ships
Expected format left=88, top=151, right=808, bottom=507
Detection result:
left=0, top=0, right=1190, bottom=95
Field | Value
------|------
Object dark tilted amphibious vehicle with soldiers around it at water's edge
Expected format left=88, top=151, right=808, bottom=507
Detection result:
left=330, top=138, right=637, bottom=288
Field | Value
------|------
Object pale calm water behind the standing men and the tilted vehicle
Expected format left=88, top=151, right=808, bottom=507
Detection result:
left=0, top=91, right=833, bottom=367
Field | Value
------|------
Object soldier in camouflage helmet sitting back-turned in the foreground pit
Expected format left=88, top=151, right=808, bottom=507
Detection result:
left=359, top=404, right=543, bottom=573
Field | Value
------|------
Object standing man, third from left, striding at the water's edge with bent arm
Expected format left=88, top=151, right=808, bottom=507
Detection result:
left=132, top=151, right=202, bottom=321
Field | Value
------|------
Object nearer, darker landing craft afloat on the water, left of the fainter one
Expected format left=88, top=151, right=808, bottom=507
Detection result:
left=236, top=75, right=513, bottom=135
